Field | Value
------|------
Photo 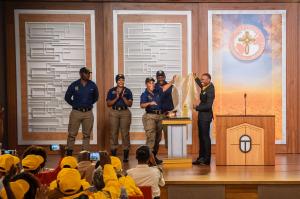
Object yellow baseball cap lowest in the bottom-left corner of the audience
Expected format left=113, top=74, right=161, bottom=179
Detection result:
left=0, top=179, right=30, bottom=199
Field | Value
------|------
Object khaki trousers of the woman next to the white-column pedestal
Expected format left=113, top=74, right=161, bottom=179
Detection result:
left=143, top=113, right=163, bottom=154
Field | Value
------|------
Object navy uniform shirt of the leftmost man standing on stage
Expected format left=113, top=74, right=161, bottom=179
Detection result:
left=65, top=79, right=99, bottom=108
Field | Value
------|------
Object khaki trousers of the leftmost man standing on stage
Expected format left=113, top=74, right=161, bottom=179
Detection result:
left=67, top=110, right=94, bottom=150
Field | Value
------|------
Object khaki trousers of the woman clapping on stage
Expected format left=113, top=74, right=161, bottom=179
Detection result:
left=109, top=109, right=131, bottom=150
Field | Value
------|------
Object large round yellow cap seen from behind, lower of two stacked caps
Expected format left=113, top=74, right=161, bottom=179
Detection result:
left=57, top=168, right=81, bottom=195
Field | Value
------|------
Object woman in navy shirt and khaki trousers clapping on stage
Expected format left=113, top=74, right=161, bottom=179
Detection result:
left=106, top=74, right=133, bottom=162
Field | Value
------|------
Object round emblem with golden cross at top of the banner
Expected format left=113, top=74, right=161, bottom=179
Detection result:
left=230, top=25, right=265, bottom=60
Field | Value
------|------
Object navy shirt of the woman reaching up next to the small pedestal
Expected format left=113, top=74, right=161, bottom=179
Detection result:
left=140, top=88, right=162, bottom=112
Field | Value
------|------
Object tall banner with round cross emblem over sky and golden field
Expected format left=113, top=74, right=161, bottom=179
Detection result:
left=208, top=10, right=286, bottom=144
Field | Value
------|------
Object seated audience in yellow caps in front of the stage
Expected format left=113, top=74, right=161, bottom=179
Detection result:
left=0, top=146, right=164, bottom=199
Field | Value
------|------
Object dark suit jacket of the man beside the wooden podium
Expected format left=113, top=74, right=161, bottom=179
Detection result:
left=195, top=78, right=215, bottom=121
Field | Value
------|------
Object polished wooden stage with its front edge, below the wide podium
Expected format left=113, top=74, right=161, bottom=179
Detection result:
left=48, top=154, right=300, bottom=199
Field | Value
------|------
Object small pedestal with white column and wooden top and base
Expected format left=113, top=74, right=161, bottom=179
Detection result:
left=162, top=118, right=192, bottom=164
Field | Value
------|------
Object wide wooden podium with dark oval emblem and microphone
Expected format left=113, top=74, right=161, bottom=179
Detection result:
left=216, top=115, right=275, bottom=165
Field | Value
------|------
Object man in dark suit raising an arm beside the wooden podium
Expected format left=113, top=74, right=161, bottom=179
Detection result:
left=193, top=73, right=215, bottom=165
